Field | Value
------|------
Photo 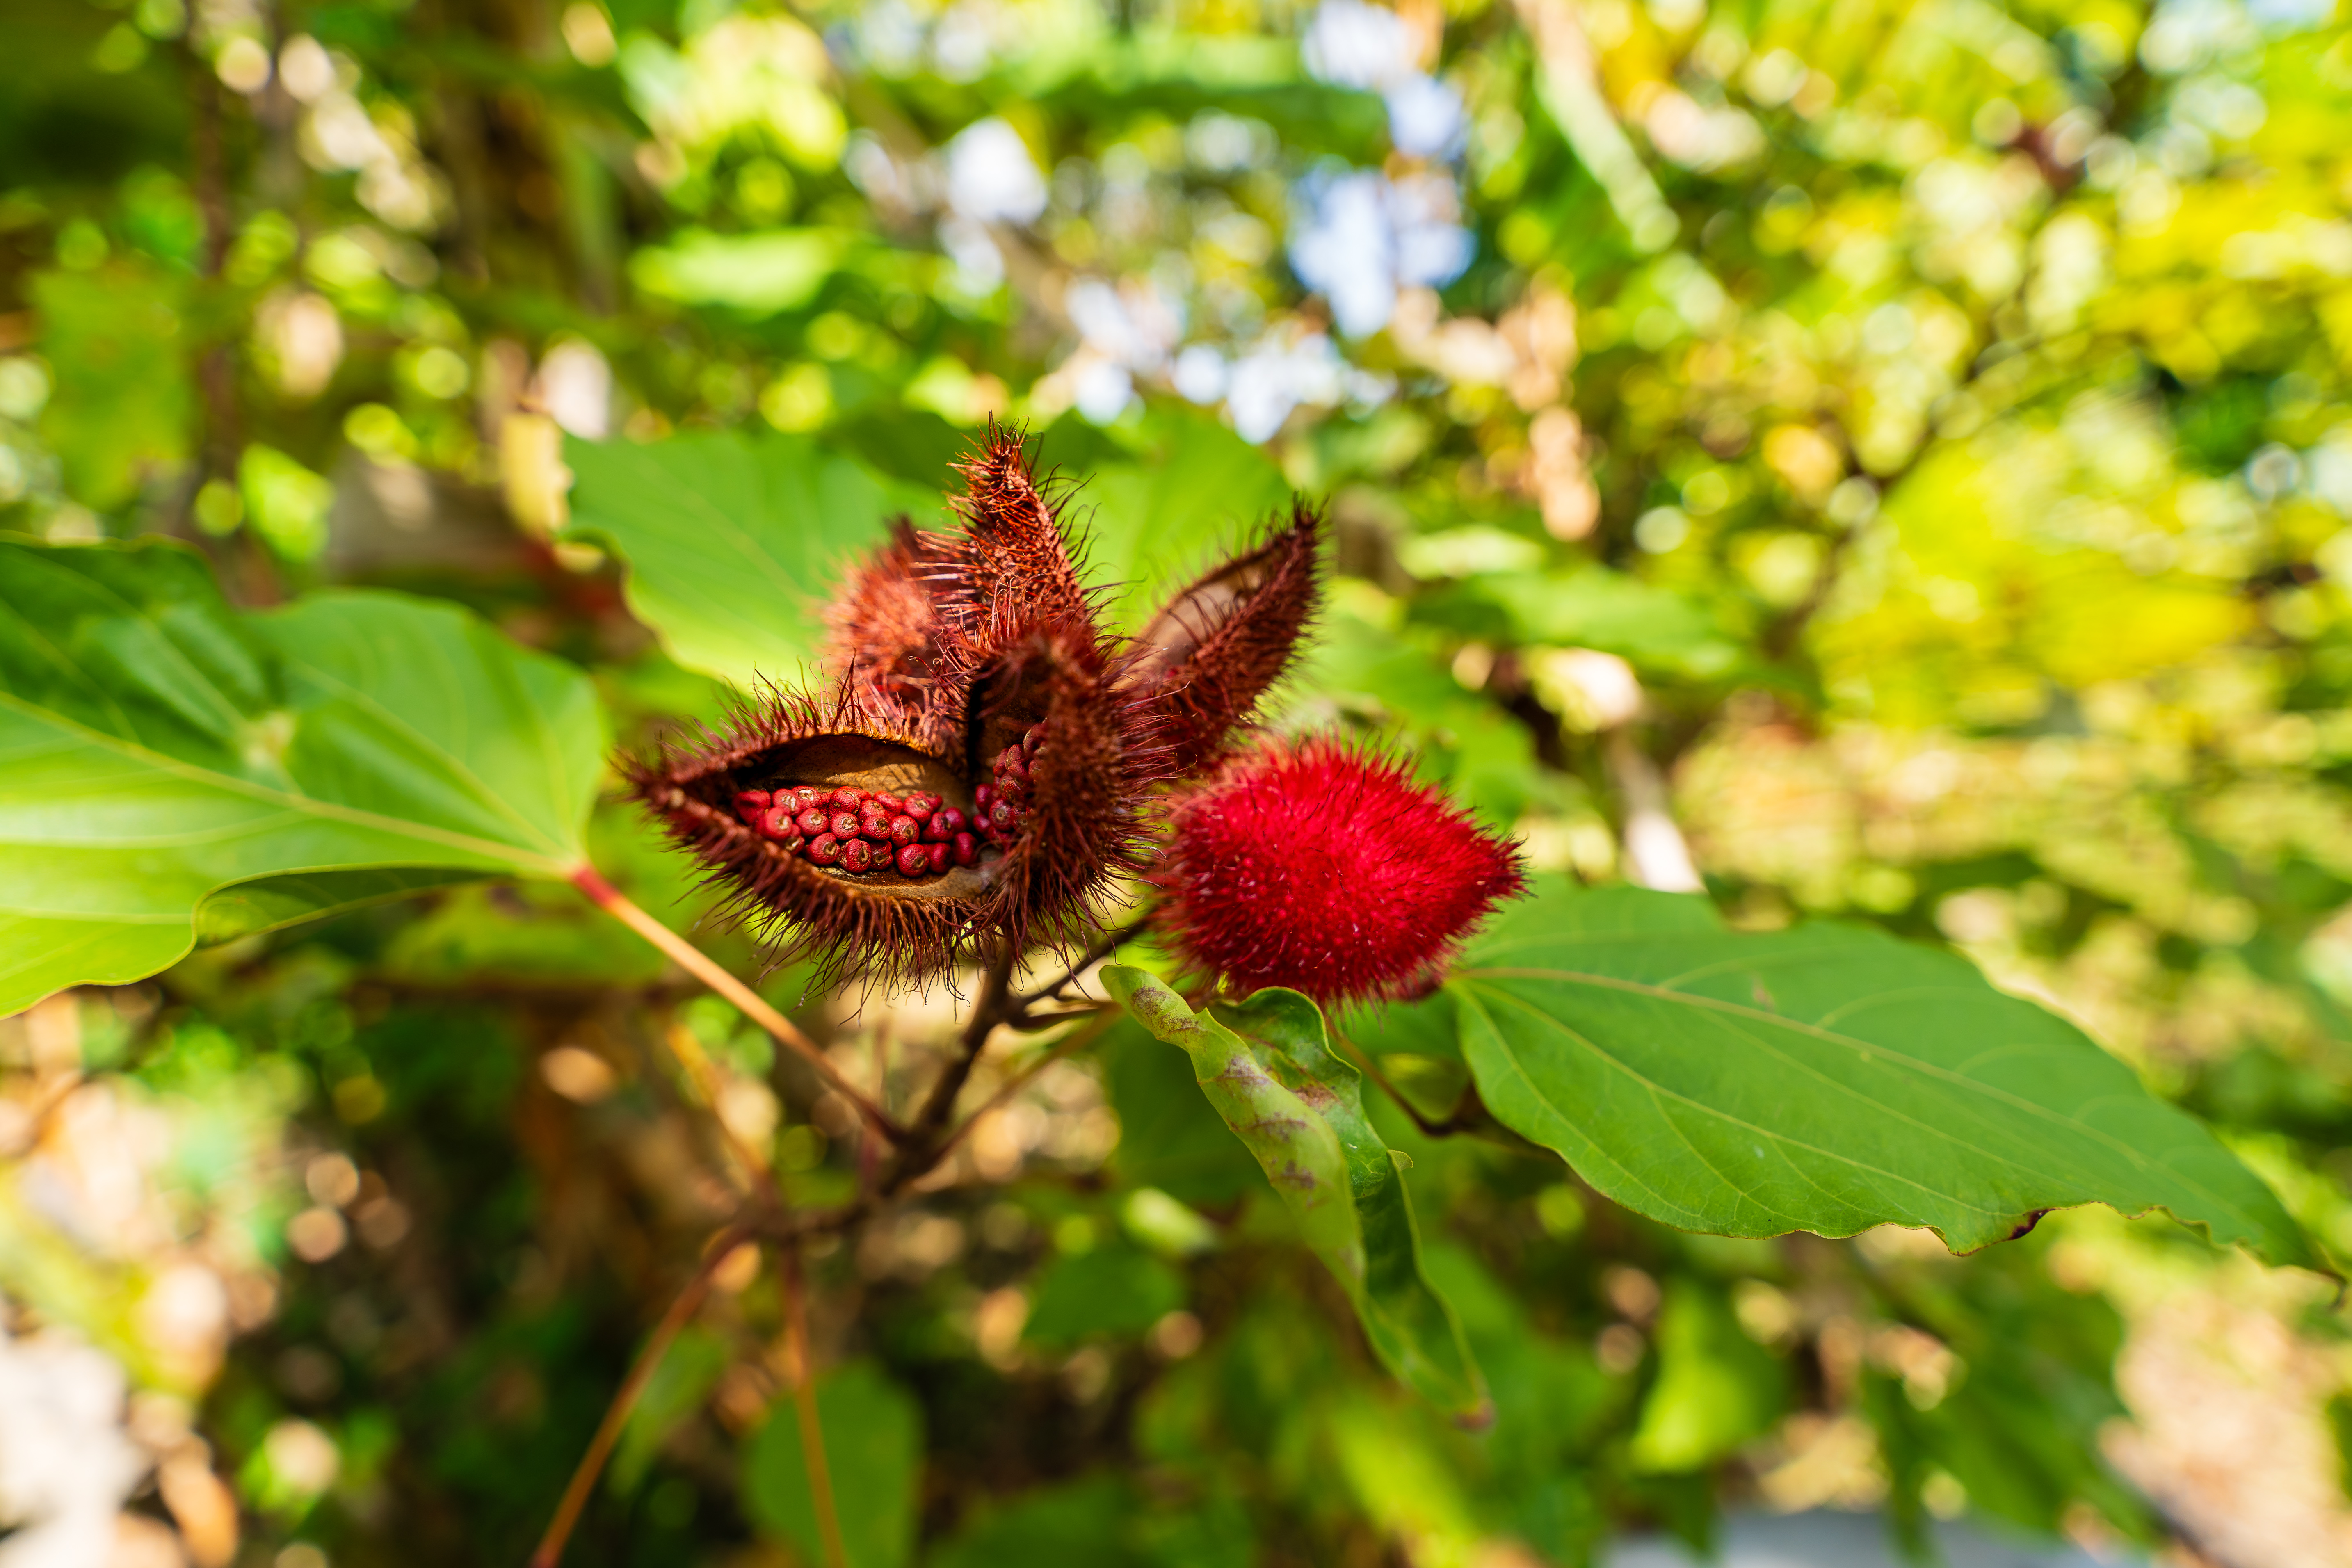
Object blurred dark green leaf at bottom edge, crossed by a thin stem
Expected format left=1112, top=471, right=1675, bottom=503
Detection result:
left=743, top=1361, right=922, bottom=1568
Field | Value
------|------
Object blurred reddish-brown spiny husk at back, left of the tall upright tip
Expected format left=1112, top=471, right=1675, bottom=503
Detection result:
left=823, top=517, right=962, bottom=745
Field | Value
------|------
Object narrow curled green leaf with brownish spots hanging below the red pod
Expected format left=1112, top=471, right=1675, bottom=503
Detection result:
left=1103, top=966, right=1493, bottom=1422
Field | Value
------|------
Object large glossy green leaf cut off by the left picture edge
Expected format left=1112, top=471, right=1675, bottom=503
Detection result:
left=0, top=541, right=605, bottom=1013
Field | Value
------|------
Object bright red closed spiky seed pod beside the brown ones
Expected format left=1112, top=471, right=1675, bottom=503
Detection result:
left=1153, top=738, right=1526, bottom=1002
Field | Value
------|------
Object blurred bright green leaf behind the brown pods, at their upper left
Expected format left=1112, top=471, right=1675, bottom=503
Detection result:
left=564, top=433, right=939, bottom=687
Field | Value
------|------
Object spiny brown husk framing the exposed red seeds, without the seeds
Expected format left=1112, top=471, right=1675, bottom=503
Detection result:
left=621, top=687, right=993, bottom=985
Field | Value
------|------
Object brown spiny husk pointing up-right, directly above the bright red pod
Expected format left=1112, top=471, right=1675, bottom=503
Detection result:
left=1124, top=501, right=1322, bottom=776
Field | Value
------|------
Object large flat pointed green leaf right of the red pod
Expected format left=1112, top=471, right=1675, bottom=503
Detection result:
left=1446, top=879, right=2324, bottom=1267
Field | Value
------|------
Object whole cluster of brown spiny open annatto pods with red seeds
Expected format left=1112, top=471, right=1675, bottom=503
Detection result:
left=623, top=425, right=1345, bottom=983
